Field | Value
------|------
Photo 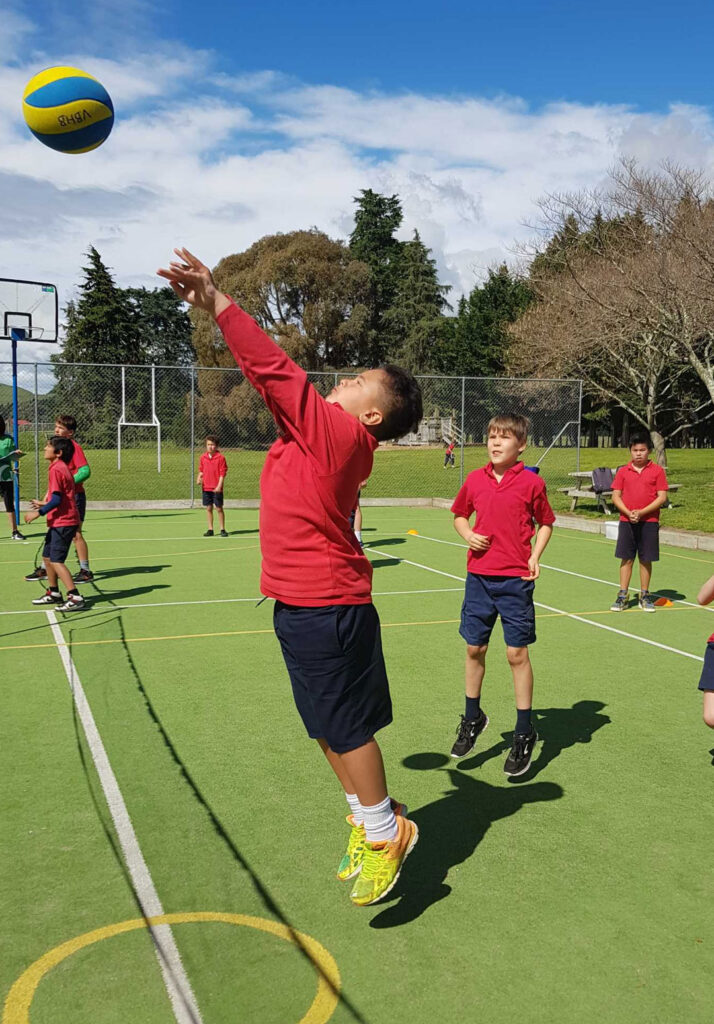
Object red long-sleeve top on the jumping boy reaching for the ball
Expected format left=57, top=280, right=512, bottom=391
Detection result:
left=217, top=303, right=378, bottom=607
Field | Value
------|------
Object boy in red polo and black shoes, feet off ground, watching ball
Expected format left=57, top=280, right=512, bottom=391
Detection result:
left=451, top=416, right=555, bottom=775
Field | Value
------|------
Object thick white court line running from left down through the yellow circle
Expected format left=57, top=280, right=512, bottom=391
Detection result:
left=46, top=611, right=202, bottom=1024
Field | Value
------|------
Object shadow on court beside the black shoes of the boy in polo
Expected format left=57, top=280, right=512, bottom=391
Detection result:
left=459, top=700, right=611, bottom=785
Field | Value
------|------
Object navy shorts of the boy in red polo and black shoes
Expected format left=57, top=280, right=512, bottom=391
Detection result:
left=459, top=572, right=536, bottom=647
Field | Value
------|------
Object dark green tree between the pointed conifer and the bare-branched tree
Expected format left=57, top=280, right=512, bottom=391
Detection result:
left=434, top=263, right=533, bottom=377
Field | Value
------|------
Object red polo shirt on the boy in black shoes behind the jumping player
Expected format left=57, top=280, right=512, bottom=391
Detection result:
left=451, top=462, right=555, bottom=577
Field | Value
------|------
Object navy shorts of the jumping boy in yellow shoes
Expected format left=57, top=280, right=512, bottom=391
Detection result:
left=272, top=601, right=391, bottom=754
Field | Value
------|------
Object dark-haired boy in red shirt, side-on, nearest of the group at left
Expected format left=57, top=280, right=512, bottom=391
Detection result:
left=25, top=436, right=84, bottom=611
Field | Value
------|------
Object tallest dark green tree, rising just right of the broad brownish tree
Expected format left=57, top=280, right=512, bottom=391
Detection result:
left=349, top=188, right=404, bottom=366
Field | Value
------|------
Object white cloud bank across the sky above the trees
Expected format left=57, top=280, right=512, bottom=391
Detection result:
left=0, top=46, right=714, bottom=374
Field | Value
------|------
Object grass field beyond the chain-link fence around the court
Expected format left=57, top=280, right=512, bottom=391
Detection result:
left=12, top=442, right=714, bottom=531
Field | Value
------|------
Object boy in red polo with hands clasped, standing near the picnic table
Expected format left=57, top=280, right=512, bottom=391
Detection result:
left=611, top=432, right=669, bottom=611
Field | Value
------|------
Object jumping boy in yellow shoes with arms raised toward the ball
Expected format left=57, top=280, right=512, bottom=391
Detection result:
left=159, top=249, right=422, bottom=906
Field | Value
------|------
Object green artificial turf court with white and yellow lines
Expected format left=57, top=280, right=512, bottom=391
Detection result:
left=0, top=505, right=714, bottom=1024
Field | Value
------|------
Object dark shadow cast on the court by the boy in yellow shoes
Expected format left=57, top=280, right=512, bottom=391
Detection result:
left=370, top=753, right=563, bottom=928
